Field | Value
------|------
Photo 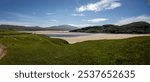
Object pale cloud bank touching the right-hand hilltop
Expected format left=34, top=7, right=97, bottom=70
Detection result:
left=116, top=15, right=150, bottom=25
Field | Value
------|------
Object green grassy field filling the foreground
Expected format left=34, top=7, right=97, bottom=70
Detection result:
left=0, top=31, right=150, bottom=65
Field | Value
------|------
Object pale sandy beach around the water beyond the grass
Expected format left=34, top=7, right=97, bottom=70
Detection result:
left=22, top=31, right=150, bottom=44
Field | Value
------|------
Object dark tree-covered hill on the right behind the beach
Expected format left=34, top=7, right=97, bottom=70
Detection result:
left=70, top=21, right=150, bottom=34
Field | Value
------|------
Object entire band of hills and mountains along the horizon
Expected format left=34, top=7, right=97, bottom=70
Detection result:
left=0, top=21, right=150, bottom=34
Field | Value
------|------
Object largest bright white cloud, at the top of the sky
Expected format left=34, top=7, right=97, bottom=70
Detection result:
left=76, top=0, right=122, bottom=12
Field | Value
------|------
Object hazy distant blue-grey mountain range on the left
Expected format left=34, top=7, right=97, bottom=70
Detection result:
left=0, top=25, right=78, bottom=31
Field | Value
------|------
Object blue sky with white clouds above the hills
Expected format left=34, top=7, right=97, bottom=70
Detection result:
left=0, top=0, right=150, bottom=27
